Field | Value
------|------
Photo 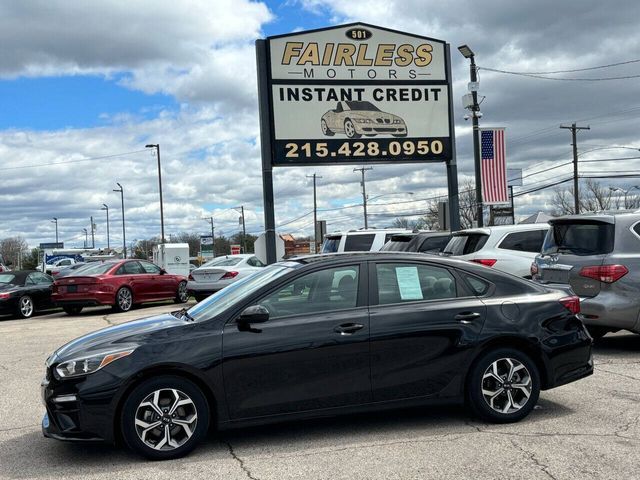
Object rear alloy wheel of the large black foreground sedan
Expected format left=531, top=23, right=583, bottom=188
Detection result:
left=482, top=358, right=533, bottom=414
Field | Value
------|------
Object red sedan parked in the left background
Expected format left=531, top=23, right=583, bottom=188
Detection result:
left=51, top=260, right=189, bottom=315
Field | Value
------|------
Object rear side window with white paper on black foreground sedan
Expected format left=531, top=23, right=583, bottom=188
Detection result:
left=376, top=263, right=456, bottom=305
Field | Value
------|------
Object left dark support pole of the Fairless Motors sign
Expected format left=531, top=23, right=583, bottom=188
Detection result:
left=256, top=40, right=277, bottom=265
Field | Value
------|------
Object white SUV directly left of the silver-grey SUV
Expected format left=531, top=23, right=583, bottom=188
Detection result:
left=442, top=223, right=549, bottom=278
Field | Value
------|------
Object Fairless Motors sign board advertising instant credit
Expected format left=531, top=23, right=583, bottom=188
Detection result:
left=264, top=23, right=452, bottom=166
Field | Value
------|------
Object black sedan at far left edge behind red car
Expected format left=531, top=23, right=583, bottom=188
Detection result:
left=0, top=270, right=54, bottom=318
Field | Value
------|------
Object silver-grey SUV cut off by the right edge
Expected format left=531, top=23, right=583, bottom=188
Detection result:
left=531, top=210, right=640, bottom=338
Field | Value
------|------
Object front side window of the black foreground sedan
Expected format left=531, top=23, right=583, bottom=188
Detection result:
left=259, top=265, right=359, bottom=318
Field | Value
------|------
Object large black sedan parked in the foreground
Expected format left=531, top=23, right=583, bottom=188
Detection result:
left=42, top=252, right=593, bottom=459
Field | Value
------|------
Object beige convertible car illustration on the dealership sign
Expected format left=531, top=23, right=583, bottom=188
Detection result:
left=320, top=101, right=407, bottom=138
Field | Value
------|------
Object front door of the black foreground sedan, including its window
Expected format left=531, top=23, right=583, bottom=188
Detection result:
left=223, top=263, right=371, bottom=420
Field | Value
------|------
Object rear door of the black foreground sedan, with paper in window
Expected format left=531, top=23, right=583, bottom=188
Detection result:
left=369, top=261, right=486, bottom=402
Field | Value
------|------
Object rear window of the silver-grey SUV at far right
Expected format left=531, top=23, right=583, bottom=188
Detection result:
left=542, top=221, right=615, bottom=255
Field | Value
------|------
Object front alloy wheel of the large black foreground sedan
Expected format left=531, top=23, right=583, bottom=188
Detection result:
left=135, top=388, right=198, bottom=451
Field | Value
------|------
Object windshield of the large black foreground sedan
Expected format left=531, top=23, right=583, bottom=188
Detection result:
left=188, top=262, right=302, bottom=322
